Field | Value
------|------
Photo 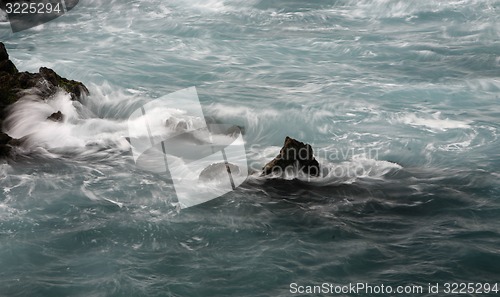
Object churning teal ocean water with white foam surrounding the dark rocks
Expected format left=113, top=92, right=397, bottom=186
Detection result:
left=0, top=0, right=500, bottom=297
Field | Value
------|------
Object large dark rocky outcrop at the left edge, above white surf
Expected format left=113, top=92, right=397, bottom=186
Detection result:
left=0, top=42, right=89, bottom=158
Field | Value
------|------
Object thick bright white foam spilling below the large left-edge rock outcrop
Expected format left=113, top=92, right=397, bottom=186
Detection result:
left=5, top=91, right=132, bottom=150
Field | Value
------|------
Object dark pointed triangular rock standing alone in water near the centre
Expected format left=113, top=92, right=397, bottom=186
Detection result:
left=262, top=136, right=320, bottom=176
